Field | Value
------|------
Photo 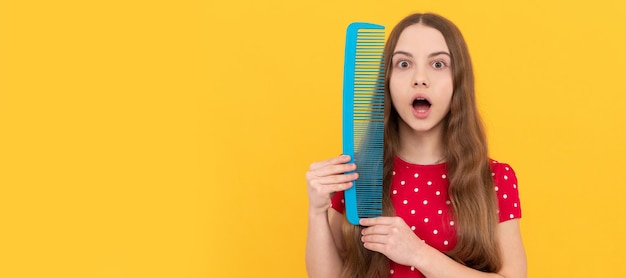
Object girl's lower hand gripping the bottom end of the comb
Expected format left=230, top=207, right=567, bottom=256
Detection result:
left=360, top=217, right=427, bottom=266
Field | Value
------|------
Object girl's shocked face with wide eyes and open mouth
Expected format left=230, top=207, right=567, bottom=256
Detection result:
left=389, top=24, right=453, bottom=132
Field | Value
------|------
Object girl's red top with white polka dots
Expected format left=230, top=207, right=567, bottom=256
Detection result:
left=332, top=157, right=522, bottom=277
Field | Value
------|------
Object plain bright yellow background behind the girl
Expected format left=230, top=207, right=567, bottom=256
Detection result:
left=0, top=0, right=626, bottom=278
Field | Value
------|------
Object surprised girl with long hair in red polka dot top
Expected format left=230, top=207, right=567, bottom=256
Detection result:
left=306, top=11, right=526, bottom=278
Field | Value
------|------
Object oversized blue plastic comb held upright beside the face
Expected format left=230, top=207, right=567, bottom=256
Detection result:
left=343, top=22, right=385, bottom=225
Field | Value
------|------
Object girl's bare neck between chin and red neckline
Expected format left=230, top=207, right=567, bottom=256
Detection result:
left=398, top=121, right=445, bottom=165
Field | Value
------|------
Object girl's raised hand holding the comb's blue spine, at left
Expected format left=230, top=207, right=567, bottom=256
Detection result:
left=306, top=155, right=358, bottom=214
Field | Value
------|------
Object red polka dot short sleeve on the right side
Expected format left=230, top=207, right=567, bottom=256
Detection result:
left=491, top=161, right=522, bottom=222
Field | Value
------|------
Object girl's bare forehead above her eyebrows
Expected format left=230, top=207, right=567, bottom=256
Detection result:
left=394, top=24, right=448, bottom=54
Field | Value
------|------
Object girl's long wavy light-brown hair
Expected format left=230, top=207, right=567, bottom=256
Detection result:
left=342, top=13, right=502, bottom=278
